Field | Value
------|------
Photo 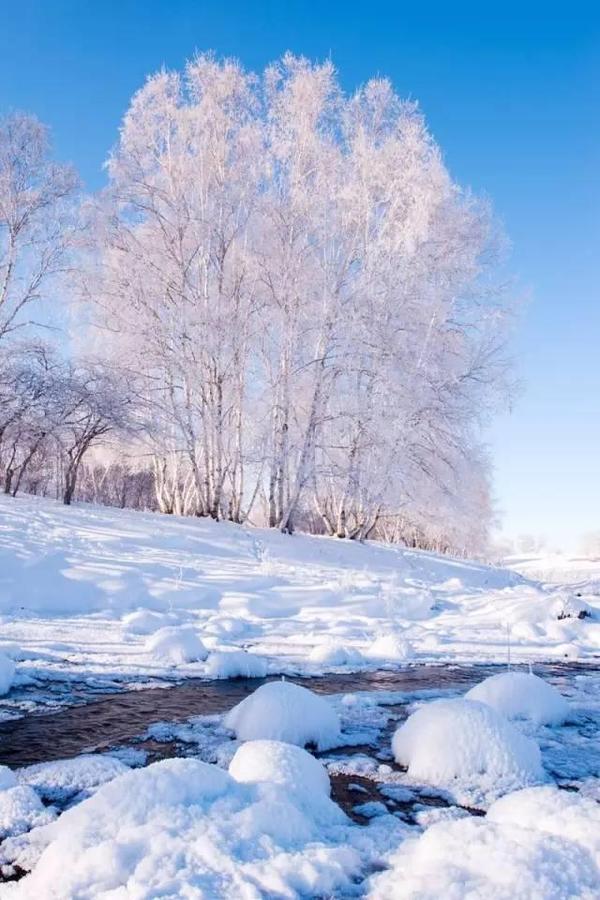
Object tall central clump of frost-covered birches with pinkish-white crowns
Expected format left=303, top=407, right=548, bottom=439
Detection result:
left=86, top=55, right=508, bottom=550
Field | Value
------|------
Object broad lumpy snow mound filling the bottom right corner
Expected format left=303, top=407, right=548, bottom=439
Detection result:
left=368, top=786, right=600, bottom=900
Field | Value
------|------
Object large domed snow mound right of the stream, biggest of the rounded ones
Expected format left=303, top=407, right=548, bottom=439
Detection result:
left=392, top=699, right=544, bottom=796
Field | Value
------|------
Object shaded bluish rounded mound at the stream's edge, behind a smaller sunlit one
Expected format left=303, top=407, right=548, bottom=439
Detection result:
left=224, top=681, right=340, bottom=750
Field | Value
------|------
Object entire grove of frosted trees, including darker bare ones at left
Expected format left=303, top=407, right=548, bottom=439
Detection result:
left=0, top=55, right=511, bottom=553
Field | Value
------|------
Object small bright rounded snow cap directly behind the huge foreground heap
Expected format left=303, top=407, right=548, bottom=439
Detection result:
left=229, top=741, right=331, bottom=797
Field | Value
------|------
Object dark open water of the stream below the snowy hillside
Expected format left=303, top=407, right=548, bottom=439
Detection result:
left=0, top=665, right=586, bottom=768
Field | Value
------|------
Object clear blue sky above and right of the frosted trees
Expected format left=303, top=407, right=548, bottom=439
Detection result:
left=0, top=0, right=600, bottom=545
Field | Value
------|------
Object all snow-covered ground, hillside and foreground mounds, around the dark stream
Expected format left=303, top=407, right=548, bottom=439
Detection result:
left=0, top=497, right=600, bottom=900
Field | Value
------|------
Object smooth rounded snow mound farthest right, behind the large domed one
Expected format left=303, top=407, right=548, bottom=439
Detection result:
left=465, top=672, right=569, bottom=725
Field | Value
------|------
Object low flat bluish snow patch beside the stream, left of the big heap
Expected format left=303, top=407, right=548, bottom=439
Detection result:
left=17, top=753, right=128, bottom=803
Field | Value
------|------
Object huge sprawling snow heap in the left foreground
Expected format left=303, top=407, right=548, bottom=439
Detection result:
left=3, top=759, right=361, bottom=900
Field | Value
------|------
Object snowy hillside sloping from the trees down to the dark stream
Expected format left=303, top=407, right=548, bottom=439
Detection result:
left=0, top=497, right=600, bottom=677
